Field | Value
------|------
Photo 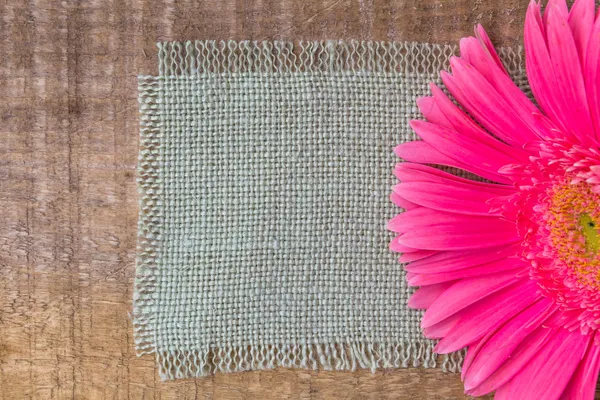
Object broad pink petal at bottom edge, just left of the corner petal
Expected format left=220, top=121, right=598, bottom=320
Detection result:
left=496, top=329, right=590, bottom=400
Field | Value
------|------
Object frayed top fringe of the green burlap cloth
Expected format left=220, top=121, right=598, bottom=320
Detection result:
left=158, top=40, right=524, bottom=78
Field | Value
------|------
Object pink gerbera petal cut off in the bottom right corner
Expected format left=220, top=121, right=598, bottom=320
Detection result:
left=561, top=344, right=600, bottom=400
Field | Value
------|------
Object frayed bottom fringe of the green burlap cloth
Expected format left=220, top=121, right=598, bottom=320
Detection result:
left=156, top=341, right=464, bottom=380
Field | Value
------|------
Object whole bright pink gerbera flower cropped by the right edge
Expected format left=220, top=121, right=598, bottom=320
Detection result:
left=389, top=0, right=600, bottom=400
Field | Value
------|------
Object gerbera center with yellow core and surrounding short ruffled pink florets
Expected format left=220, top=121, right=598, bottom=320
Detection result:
left=503, top=140, right=600, bottom=334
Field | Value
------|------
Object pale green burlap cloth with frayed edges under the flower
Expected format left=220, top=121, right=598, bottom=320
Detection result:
left=134, top=41, right=526, bottom=379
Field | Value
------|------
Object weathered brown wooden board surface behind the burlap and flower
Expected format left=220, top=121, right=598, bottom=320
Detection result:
left=0, top=0, right=592, bottom=400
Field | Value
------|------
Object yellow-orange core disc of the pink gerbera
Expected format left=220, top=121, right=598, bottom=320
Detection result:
left=546, top=182, right=600, bottom=289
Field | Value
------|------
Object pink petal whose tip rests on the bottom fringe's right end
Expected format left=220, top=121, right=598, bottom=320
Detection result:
left=435, top=278, right=540, bottom=354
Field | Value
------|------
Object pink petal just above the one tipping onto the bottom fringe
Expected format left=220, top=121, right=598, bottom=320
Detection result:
left=421, top=271, right=521, bottom=328
